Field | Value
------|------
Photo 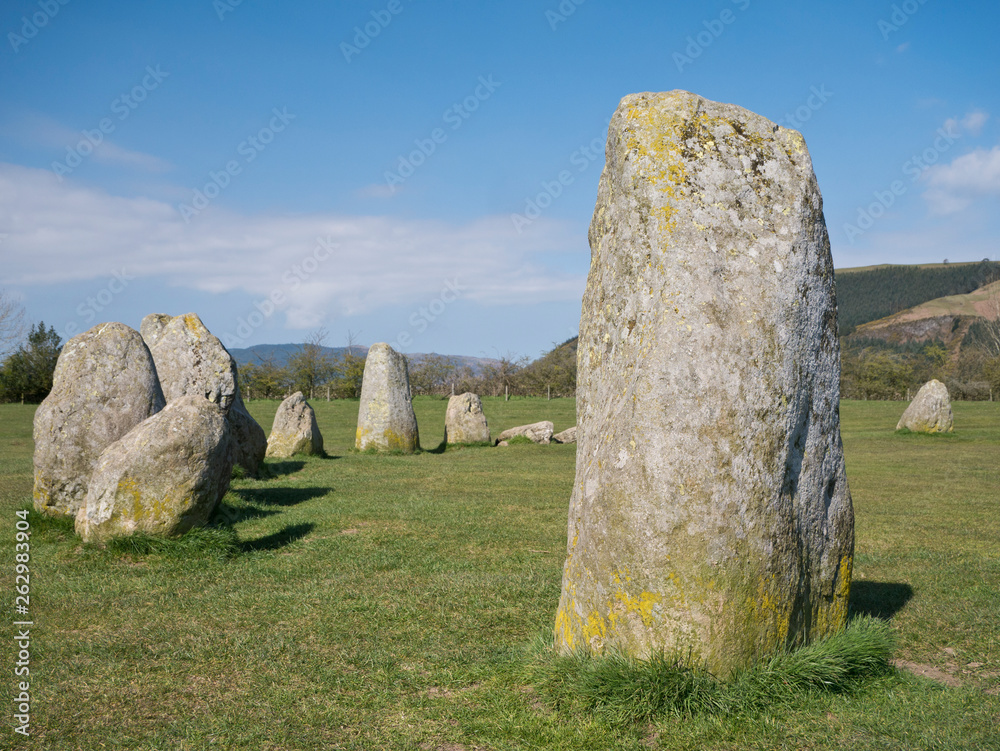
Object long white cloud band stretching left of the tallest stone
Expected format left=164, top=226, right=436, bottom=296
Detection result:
left=0, top=163, right=589, bottom=328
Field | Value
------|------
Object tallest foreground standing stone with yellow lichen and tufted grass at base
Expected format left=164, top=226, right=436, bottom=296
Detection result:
left=555, top=91, right=854, bottom=675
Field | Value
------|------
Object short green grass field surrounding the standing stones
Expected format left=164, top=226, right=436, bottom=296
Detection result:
left=0, top=398, right=1000, bottom=751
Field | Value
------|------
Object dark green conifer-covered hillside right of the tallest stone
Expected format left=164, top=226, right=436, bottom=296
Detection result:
left=836, top=259, right=1000, bottom=336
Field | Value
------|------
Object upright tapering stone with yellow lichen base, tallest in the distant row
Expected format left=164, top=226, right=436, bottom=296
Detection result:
left=355, top=342, right=420, bottom=452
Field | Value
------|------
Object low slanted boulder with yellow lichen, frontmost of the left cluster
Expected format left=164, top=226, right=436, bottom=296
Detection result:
left=76, top=395, right=233, bottom=541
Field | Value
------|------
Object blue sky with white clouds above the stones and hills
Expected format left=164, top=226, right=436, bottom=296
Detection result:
left=0, top=0, right=1000, bottom=356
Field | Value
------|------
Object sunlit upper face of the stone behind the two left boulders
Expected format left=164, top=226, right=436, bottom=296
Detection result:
left=147, top=313, right=237, bottom=411
